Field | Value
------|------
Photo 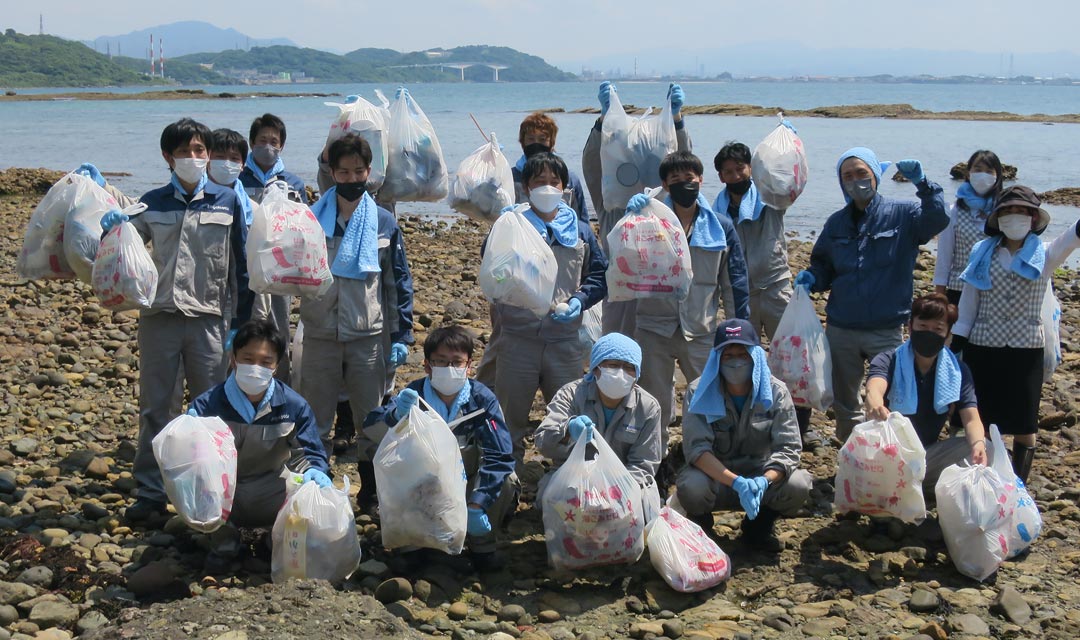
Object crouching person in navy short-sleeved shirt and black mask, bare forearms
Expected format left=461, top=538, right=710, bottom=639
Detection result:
left=866, top=294, right=986, bottom=485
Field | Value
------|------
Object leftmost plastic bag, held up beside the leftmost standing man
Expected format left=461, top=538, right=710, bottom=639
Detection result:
left=15, top=173, right=88, bottom=280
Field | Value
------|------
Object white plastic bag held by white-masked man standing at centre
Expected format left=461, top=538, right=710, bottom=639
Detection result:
left=477, top=204, right=558, bottom=316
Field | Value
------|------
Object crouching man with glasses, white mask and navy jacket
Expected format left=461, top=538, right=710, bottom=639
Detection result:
left=360, top=325, right=518, bottom=570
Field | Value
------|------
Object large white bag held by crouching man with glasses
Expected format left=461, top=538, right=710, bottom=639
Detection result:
left=375, top=398, right=469, bottom=555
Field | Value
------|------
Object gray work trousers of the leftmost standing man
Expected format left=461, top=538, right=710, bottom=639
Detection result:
left=133, top=312, right=226, bottom=502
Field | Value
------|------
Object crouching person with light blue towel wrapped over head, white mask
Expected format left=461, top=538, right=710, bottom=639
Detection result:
left=536, top=333, right=662, bottom=504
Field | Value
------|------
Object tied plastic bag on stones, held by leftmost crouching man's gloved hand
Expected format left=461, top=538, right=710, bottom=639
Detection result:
left=270, top=471, right=361, bottom=583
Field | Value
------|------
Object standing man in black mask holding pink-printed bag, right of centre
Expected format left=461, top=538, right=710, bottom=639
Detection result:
left=626, top=151, right=750, bottom=451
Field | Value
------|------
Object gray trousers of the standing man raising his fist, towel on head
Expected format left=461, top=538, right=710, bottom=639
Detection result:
left=825, top=325, right=904, bottom=442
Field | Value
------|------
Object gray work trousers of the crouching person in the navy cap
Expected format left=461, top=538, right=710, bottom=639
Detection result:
left=675, top=465, right=813, bottom=516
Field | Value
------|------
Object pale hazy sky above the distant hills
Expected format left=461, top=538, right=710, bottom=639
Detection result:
left=8, top=0, right=1080, bottom=63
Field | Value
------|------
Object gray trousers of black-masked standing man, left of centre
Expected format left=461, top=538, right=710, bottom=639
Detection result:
left=300, top=333, right=387, bottom=461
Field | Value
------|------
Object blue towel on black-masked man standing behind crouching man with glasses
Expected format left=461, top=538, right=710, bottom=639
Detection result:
left=311, top=187, right=382, bottom=280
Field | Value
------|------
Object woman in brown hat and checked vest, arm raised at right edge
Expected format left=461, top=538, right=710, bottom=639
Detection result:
left=953, top=185, right=1080, bottom=482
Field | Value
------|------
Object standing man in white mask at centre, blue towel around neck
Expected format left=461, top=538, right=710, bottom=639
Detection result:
left=481, top=152, right=608, bottom=475
